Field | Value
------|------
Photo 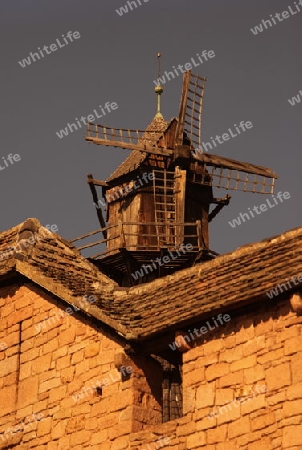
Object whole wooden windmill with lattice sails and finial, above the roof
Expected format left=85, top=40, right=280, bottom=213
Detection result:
left=73, top=59, right=277, bottom=285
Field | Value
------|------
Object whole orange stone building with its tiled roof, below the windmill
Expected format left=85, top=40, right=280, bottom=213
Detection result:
left=0, top=222, right=302, bottom=450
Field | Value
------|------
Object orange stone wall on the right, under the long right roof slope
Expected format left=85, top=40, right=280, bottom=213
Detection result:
left=130, top=299, right=302, bottom=450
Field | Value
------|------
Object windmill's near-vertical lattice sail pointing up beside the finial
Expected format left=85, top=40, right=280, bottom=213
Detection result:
left=177, top=70, right=206, bottom=148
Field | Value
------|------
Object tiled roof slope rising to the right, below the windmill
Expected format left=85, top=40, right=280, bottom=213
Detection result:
left=125, top=228, right=302, bottom=339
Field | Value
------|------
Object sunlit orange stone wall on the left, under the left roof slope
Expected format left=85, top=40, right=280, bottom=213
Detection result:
left=0, top=284, right=161, bottom=450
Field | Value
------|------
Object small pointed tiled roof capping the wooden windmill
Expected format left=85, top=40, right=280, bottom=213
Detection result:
left=106, top=116, right=168, bottom=182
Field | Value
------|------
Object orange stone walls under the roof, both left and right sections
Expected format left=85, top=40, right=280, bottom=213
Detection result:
left=0, top=283, right=302, bottom=450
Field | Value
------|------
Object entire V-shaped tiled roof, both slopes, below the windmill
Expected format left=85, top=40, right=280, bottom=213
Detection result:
left=0, top=219, right=302, bottom=340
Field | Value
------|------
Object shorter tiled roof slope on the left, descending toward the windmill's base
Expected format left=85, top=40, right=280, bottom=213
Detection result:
left=0, top=219, right=127, bottom=334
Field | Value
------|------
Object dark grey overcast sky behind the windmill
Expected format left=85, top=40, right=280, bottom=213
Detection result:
left=0, top=0, right=302, bottom=253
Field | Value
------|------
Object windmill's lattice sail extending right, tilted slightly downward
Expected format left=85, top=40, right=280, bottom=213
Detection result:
left=192, top=152, right=278, bottom=194
